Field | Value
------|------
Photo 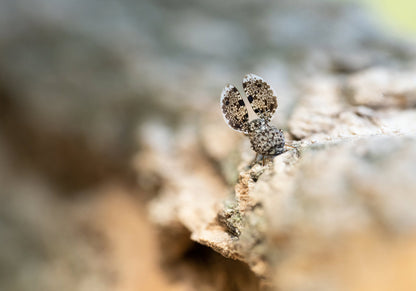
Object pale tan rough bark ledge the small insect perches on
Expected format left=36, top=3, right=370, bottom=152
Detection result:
left=136, top=9, right=416, bottom=290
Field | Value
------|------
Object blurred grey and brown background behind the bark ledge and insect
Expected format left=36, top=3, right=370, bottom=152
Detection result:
left=0, top=0, right=416, bottom=291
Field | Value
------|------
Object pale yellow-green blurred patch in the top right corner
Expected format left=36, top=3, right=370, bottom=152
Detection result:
left=359, top=0, right=416, bottom=36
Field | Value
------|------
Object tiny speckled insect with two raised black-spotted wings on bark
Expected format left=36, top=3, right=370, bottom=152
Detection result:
left=221, top=74, right=285, bottom=165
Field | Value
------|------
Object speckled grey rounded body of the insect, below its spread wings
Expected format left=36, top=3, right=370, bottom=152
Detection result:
left=248, top=118, right=285, bottom=156
